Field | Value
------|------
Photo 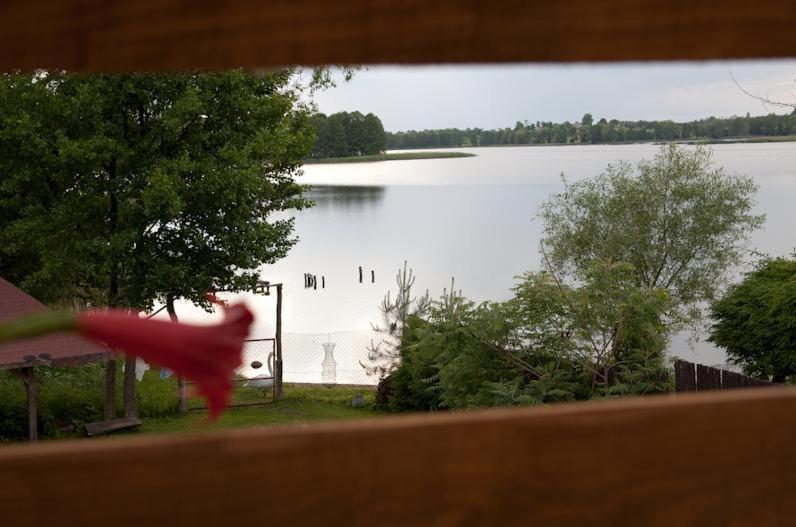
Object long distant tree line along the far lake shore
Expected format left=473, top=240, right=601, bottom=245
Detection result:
left=387, top=110, right=796, bottom=149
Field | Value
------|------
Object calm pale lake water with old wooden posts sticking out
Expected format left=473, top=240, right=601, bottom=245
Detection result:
left=174, top=143, right=796, bottom=382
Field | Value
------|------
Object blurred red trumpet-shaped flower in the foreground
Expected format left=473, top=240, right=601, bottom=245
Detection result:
left=77, top=304, right=254, bottom=419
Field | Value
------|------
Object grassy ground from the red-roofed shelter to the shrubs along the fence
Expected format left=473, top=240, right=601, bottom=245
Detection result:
left=0, top=364, right=377, bottom=444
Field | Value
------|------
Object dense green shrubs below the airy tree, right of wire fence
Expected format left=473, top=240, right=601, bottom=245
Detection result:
left=386, top=261, right=673, bottom=411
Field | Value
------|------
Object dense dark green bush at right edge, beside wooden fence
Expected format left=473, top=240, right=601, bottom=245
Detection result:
left=708, top=258, right=796, bottom=382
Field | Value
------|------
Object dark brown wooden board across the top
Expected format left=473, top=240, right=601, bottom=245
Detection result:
left=0, top=0, right=796, bottom=71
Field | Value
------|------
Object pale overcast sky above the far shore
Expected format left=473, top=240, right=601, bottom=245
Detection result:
left=316, top=59, right=796, bottom=131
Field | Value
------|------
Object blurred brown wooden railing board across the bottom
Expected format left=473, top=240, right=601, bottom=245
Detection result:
left=0, top=389, right=796, bottom=527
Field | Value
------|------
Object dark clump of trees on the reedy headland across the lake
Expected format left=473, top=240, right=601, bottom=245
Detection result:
left=310, top=112, right=387, bottom=158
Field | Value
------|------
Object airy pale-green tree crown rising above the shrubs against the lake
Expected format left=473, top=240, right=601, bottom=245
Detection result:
left=540, top=145, right=764, bottom=319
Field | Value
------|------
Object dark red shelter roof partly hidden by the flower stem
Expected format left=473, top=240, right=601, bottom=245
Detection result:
left=0, top=278, right=109, bottom=369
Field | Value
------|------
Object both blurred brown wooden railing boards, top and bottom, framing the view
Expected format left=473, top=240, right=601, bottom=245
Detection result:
left=0, top=0, right=796, bottom=527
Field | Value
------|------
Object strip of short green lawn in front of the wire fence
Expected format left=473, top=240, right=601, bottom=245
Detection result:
left=130, top=385, right=383, bottom=434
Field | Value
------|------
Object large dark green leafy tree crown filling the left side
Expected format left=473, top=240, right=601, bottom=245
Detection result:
left=0, top=69, right=314, bottom=309
